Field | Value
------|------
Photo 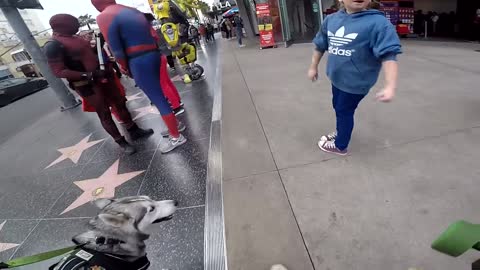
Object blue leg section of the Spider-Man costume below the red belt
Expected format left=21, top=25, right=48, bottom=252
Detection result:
left=129, top=52, right=172, bottom=116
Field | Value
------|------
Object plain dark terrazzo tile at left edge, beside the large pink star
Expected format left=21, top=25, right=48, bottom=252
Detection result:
left=0, top=166, right=83, bottom=219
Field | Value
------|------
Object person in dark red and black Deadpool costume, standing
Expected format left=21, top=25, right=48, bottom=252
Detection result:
left=44, top=14, right=153, bottom=154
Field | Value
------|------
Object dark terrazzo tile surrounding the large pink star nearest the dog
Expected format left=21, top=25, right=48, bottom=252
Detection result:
left=44, top=151, right=155, bottom=218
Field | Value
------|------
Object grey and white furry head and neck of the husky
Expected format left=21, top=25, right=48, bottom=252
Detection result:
left=51, top=196, right=177, bottom=270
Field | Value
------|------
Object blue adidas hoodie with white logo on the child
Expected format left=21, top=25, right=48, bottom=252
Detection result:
left=313, top=10, right=402, bottom=95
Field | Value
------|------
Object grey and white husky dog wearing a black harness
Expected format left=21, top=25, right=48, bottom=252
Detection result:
left=50, top=196, right=178, bottom=270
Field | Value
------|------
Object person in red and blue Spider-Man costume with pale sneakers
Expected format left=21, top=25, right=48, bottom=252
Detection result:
left=92, top=0, right=187, bottom=153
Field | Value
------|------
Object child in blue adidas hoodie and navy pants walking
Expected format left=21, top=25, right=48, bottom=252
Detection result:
left=308, top=0, right=401, bottom=155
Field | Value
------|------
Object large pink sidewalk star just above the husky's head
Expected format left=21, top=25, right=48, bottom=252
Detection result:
left=60, top=160, right=145, bottom=215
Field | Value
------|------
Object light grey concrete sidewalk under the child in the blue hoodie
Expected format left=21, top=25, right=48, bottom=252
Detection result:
left=222, top=38, right=480, bottom=270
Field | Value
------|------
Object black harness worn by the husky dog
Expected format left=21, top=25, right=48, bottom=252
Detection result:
left=49, top=248, right=150, bottom=270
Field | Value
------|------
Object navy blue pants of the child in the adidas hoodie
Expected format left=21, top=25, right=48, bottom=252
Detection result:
left=332, top=85, right=365, bottom=150
